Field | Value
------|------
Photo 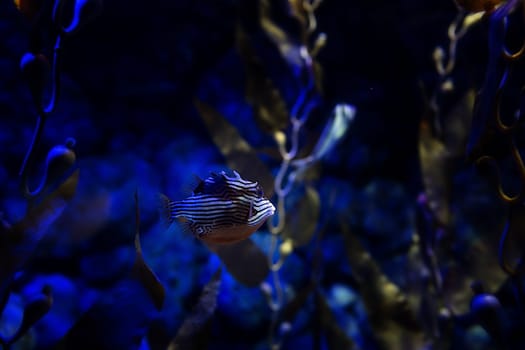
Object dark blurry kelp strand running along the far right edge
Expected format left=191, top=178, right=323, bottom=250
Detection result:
left=467, top=1, right=525, bottom=348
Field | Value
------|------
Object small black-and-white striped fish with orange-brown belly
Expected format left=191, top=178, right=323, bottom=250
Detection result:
left=164, top=171, right=275, bottom=244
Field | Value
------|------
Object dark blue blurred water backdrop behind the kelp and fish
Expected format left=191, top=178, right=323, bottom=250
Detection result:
left=0, top=0, right=500, bottom=349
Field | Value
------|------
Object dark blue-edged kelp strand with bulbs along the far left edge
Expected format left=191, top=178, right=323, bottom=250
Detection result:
left=0, top=0, right=99, bottom=348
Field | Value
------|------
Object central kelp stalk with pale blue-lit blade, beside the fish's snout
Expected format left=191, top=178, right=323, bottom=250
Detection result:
left=191, top=0, right=356, bottom=349
